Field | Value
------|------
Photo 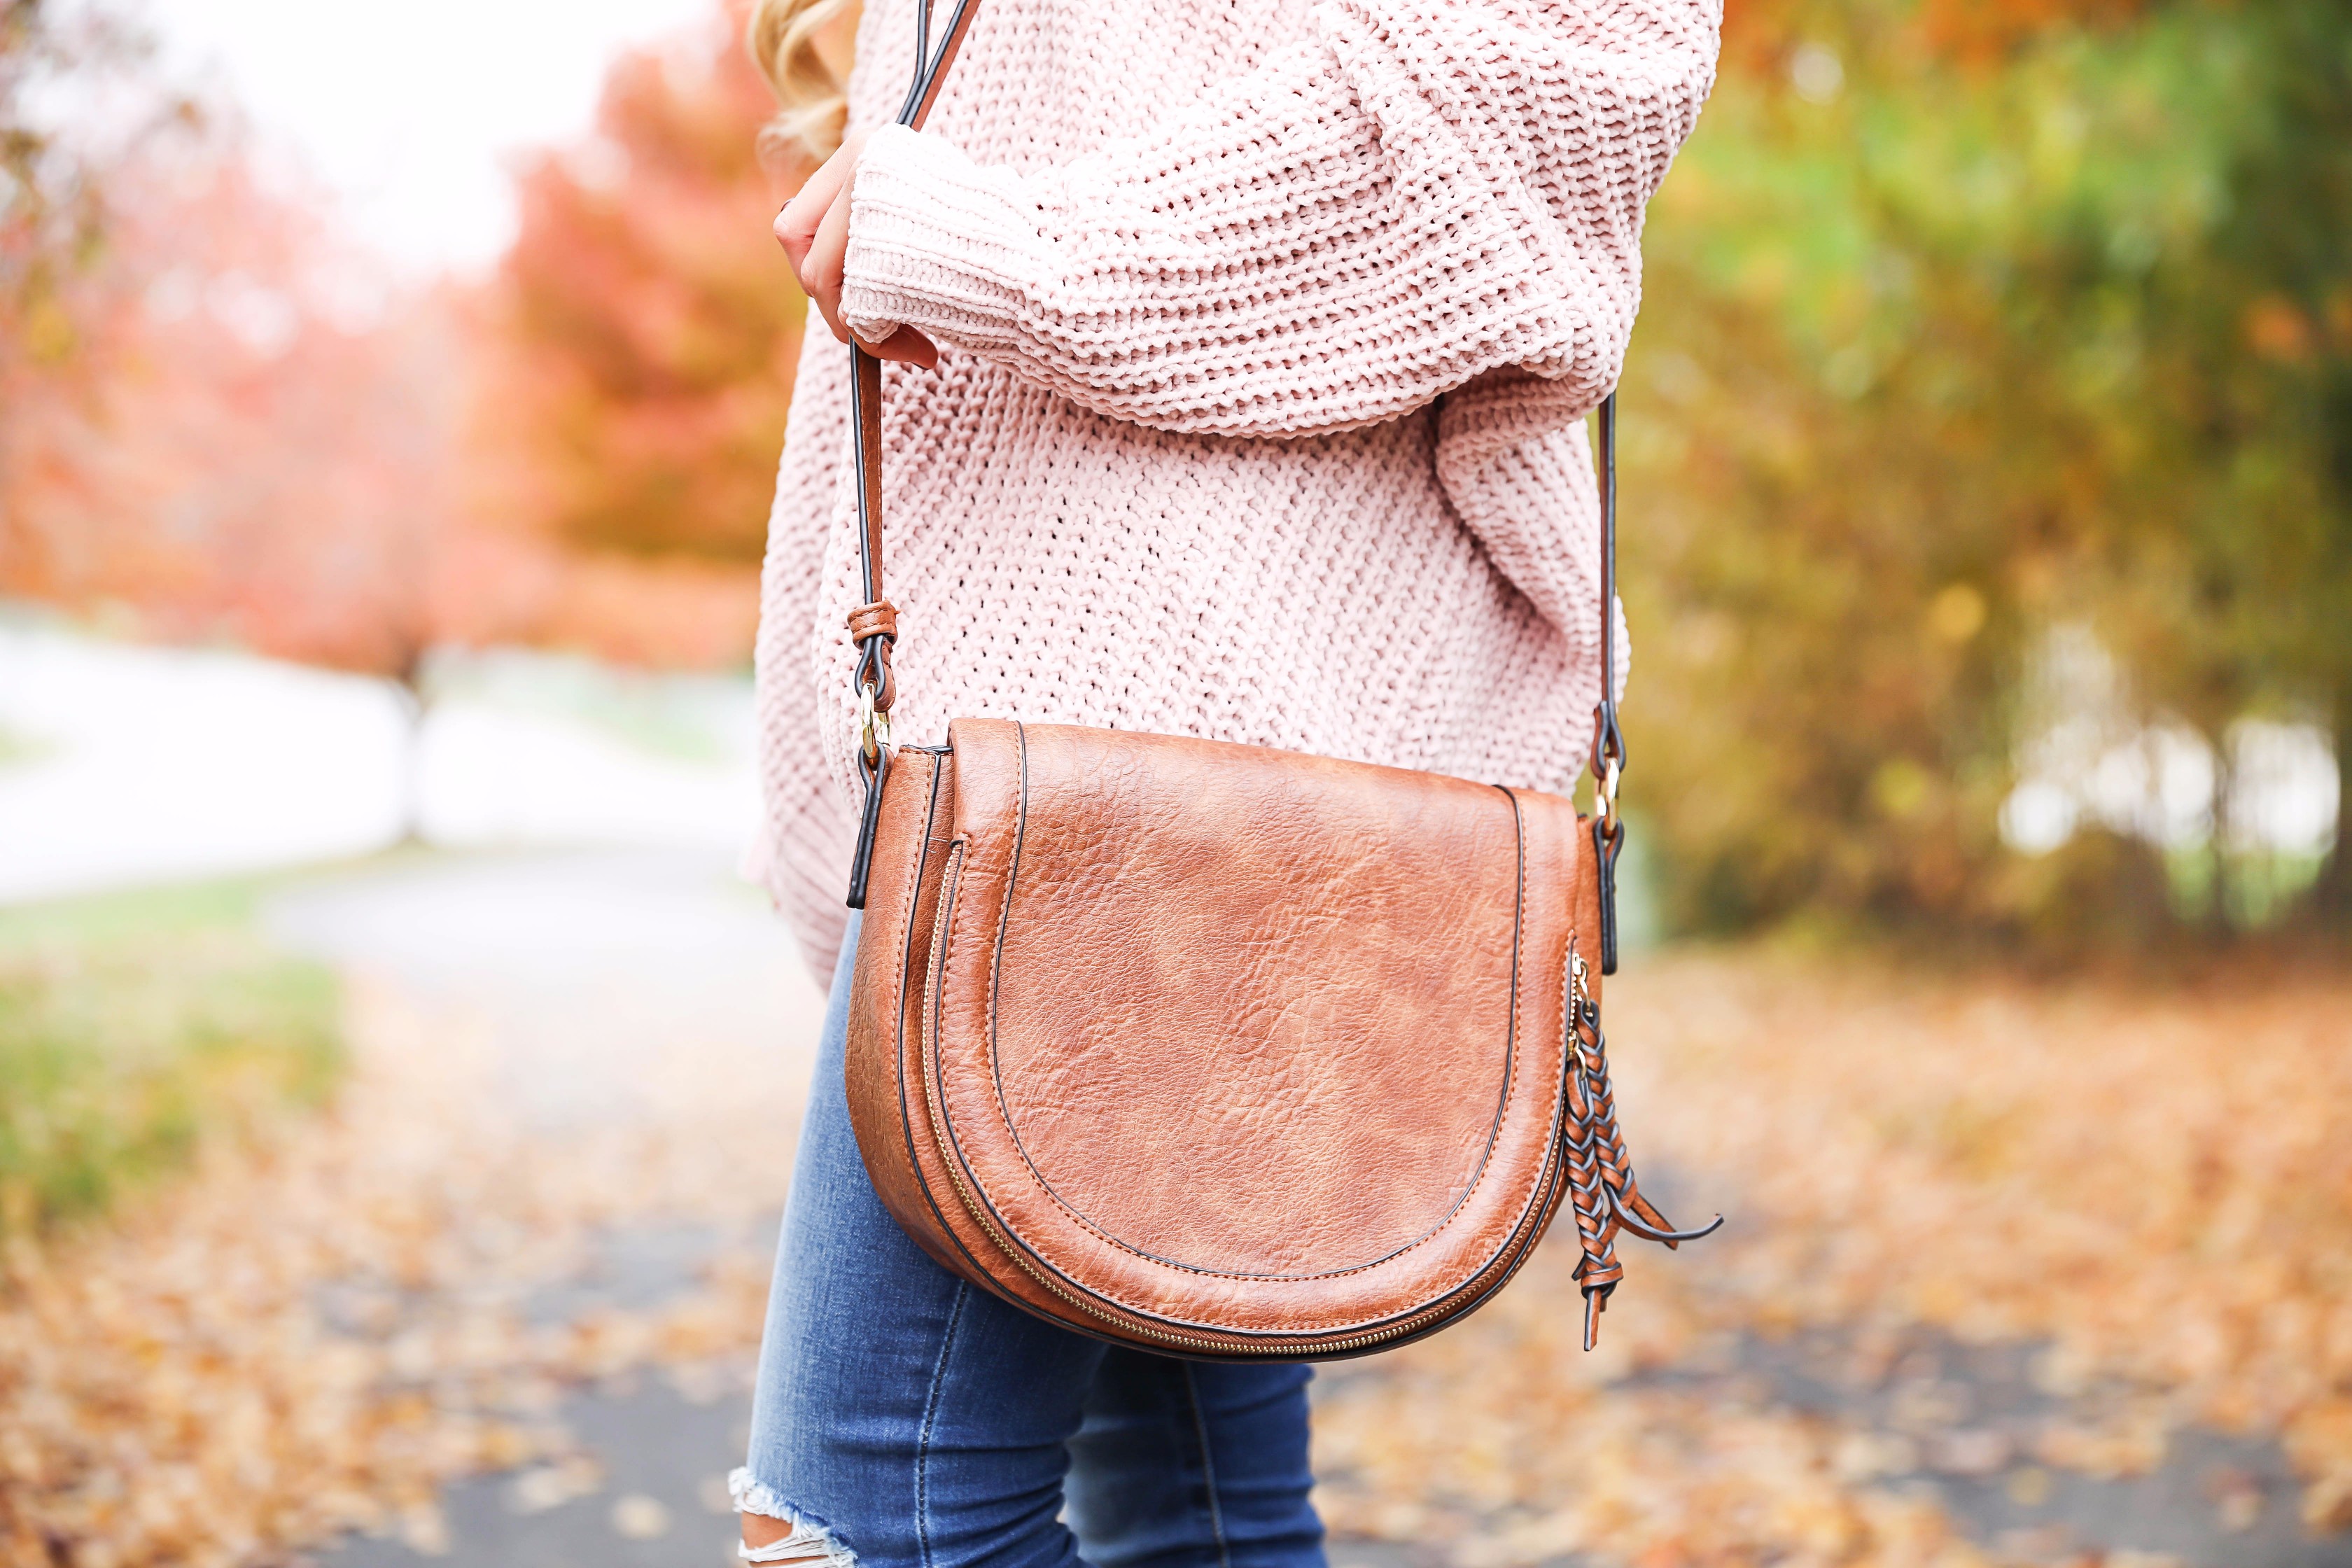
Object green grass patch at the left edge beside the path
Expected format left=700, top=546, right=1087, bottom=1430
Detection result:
left=0, top=884, right=344, bottom=1236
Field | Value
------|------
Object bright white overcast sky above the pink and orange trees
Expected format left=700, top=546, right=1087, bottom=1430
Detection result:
left=144, top=0, right=715, bottom=270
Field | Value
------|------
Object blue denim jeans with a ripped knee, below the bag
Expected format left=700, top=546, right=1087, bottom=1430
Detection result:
left=734, top=919, right=1324, bottom=1568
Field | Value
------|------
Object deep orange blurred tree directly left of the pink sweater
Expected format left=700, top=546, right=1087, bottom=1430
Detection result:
left=479, top=17, right=802, bottom=566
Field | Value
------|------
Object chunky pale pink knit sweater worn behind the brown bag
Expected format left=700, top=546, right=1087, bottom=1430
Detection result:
left=755, top=0, right=1719, bottom=971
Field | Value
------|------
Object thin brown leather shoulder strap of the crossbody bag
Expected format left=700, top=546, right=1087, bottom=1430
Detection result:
left=849, top=0, right=1625, bottom=949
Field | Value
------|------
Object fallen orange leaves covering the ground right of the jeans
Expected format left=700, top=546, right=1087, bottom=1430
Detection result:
left=1320, top=952, right=2352, bottom=1566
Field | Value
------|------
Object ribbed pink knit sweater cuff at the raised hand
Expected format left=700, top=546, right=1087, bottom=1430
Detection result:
left=842, top=125, right=1046, bottom=350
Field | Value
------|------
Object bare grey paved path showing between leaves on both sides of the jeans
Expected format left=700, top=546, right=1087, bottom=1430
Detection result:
left=268, top=851, right=2352, bottom=1568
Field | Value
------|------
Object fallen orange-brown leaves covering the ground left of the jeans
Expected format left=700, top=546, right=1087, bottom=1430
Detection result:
left=0, top=968, right=785, bottom=1568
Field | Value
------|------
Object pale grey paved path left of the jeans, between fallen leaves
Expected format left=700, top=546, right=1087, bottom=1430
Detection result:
left=266, top=851, right=823, bottom=1568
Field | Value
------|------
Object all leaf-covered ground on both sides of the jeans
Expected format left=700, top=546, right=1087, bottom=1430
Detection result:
left=0, top=879, right=2352, bottom=1568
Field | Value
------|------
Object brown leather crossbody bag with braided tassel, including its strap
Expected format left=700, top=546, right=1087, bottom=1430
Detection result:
left=849, top=0, right=1722, bottom=1359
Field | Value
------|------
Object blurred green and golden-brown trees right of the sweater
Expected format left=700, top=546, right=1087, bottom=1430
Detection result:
left=1628, top=0, right=2352, bottom=940
